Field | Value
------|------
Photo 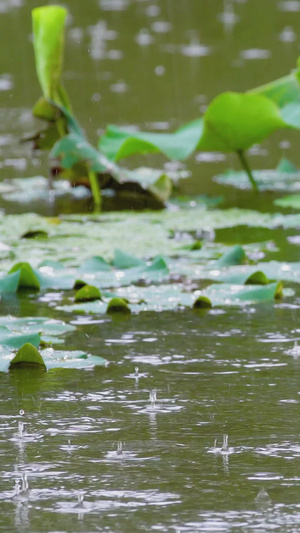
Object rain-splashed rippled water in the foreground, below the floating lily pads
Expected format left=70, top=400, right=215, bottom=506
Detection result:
left=0, top=304, right=300, bottom=532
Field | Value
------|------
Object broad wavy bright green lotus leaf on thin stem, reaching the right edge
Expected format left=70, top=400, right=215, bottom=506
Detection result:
left=99, top=66, right=300, bottom=189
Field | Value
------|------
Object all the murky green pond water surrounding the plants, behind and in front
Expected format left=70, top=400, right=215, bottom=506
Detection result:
left=0, top=0, right=300, bottom=533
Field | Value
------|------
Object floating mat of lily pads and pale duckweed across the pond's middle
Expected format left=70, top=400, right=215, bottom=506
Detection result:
left=0, top=200, right=300, bottom=370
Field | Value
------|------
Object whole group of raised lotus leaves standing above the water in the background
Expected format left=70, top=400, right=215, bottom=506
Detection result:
left=27, top=6, right=300, bottom=209
